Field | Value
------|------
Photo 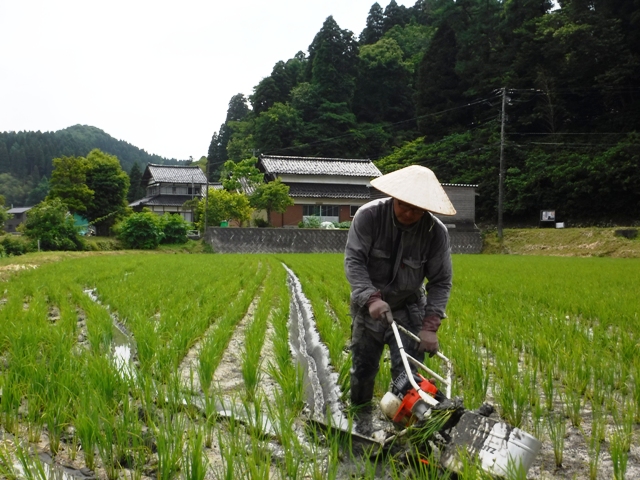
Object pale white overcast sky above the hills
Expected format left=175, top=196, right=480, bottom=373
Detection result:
left=0, top=0, right=415, bottom=159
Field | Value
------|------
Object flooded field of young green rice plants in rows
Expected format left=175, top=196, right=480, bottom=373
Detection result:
left=0, top=254, right=640, bottom=478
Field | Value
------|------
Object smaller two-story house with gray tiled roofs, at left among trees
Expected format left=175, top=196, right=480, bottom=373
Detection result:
left=129, top=163, right=207, bottom=222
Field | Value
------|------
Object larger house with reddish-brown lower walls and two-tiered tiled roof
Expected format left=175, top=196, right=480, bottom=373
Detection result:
left=257, top=155, right=382, bottom=227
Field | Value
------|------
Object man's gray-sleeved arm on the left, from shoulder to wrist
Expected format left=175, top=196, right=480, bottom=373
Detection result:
left=344, top=210, right=378, bottom=307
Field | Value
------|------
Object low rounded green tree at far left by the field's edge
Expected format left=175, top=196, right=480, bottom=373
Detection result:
left=19, top=198, right=84, bottom=250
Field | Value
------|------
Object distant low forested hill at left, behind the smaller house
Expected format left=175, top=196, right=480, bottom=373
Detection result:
left=0, top=125, right=185, bottom=206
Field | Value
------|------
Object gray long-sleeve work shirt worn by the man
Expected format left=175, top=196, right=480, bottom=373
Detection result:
left=344, top=198, right=453, bottom=318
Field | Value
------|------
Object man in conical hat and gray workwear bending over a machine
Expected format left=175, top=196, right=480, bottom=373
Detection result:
left=344, top=165, right=456, bottom=424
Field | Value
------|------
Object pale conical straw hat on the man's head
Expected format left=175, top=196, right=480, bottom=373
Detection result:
left=371, top=165, right=456, bottom=215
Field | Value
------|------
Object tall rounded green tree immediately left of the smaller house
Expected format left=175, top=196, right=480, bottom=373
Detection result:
left=86, top=149, right=129, bottom=235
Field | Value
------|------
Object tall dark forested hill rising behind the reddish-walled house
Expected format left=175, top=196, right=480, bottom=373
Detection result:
left=208, top=0, right=640, bottom=221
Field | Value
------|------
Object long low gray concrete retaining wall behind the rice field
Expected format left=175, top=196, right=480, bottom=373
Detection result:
left=204, top=227, right=482, bottom=253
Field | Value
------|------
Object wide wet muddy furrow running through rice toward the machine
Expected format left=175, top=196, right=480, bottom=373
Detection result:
left=284, top=265, right=349, bottom=429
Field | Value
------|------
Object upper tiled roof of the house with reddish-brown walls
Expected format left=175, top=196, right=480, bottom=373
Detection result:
left=259, top=155, right=382, bottom=178
